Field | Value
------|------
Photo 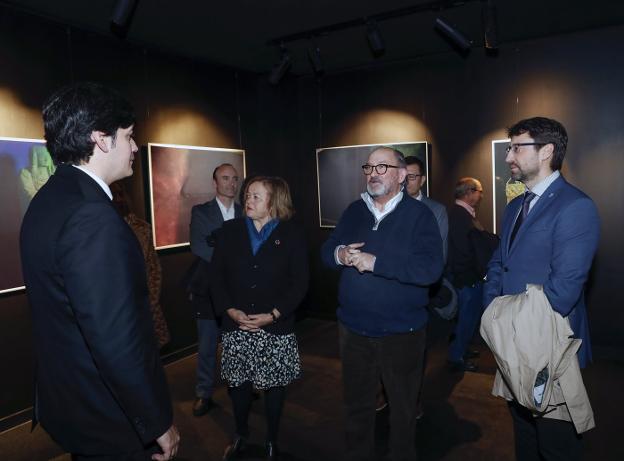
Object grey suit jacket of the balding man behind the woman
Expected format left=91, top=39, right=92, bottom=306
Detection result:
left=189, top=198, right=243, bottom=319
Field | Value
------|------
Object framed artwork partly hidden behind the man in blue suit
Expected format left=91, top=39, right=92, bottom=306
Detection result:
left=492, top=139, right=525, bottom=234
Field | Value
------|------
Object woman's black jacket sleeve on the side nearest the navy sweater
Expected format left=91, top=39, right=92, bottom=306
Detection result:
left=275, top=226, right=310, bottom=317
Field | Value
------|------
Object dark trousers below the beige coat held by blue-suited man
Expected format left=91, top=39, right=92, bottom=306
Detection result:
left=509, top=401, right=583, bottom=461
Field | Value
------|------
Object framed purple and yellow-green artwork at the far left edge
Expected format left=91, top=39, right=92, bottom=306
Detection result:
left=0, top=137, right=56, bottom=293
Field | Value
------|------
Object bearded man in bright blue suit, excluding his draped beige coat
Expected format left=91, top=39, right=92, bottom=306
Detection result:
left=484, top=117, right=600, bottom=461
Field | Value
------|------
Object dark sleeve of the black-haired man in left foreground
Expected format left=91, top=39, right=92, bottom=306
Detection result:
left=56, top=202, right=173, bottom=444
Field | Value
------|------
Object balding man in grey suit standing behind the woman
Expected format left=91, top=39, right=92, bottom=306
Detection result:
left=191, top=163, right=242, bottom=416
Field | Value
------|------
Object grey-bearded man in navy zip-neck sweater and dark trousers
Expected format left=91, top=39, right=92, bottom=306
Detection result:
left=321, top=147, right=444, bottom=461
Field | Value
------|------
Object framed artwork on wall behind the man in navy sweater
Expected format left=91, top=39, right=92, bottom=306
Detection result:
left=316, top=141, right=431, bottom=227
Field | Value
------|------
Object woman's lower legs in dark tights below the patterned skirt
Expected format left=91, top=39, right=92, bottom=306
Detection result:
left=228, top=381, right=286, bottom=443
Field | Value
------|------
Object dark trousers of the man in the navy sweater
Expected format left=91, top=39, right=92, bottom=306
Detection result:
left=339, top=324, right=425, bottom=461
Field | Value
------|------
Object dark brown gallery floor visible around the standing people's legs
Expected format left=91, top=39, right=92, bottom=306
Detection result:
left=0, top=319, right=624, bottom=461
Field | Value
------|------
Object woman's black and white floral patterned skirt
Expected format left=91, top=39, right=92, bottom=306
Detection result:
left=221, top=330, right=301, bottom=389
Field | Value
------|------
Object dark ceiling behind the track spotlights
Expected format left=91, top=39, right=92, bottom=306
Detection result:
left=3, top=0, right=624, bottom=74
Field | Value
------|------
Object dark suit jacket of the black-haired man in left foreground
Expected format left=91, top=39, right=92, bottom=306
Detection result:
left=21, top=165, right=172, bottom=455
